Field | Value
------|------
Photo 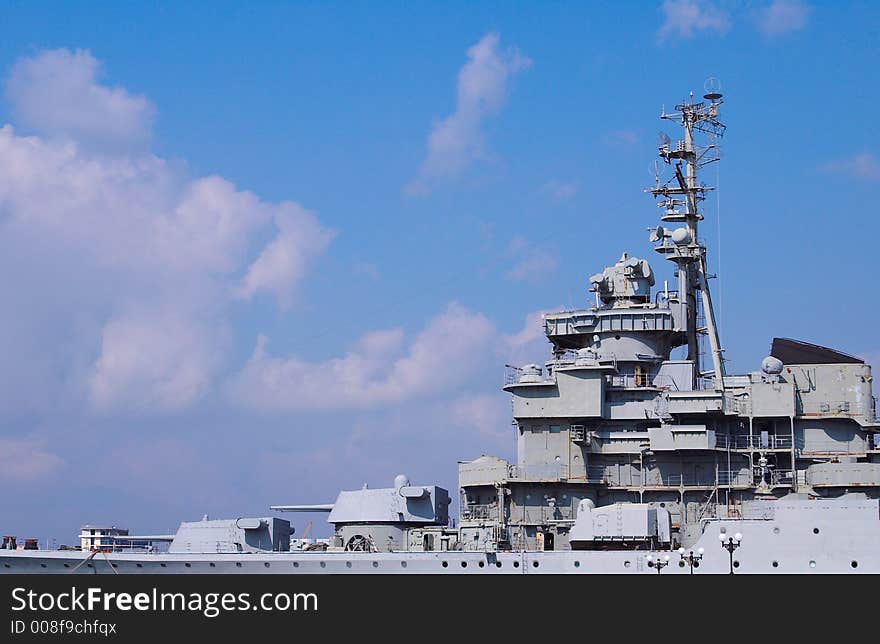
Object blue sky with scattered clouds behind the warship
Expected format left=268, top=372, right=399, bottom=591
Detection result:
left=0, top=0, right=880, bottom=542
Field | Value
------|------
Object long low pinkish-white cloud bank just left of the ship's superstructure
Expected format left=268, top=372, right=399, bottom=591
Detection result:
left=229, top=302, right=495, bottom=412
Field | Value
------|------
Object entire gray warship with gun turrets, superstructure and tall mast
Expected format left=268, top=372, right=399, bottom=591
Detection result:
left=0, top=91, right=880, bottom=574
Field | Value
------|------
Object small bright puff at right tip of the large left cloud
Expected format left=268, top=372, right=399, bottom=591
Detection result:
left=239, top=203, right=335, bottom=307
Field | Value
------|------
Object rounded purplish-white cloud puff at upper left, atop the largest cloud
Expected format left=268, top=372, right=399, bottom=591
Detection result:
left=6, top=49, right=155, bottom=147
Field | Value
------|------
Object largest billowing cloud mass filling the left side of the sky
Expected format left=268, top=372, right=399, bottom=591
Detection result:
left=0, top=50, right=333, bottom=411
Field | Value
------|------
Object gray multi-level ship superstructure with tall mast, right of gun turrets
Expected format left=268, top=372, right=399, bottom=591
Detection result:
left=459, top=92, right=880, bottom=550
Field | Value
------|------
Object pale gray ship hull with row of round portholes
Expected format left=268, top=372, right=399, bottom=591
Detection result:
left=6, top=500, right=880, bottom=575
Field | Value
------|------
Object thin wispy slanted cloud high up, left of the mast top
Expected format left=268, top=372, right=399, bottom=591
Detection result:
left=406, top=33, right=531, bottom=194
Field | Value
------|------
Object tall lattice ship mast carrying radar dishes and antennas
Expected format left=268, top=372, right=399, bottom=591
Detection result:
left=648, top=88, right=725, bottom=391
